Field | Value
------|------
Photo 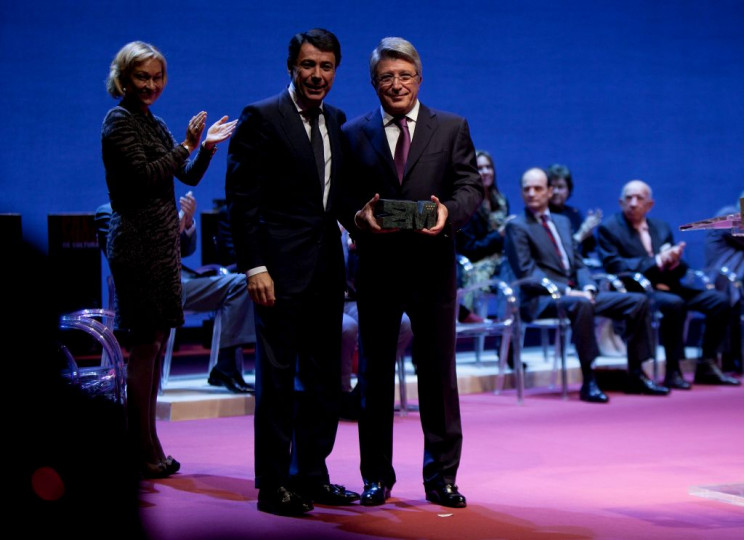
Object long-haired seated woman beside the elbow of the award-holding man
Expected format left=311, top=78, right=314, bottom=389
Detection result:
left=457, top=150, right=513, bottom=323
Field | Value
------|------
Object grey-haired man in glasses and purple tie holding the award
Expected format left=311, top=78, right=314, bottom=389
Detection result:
left=344, top=38, right=483, bottom=507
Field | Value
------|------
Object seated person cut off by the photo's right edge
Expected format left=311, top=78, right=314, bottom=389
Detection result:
left=705, top=191, right=744, bottom=374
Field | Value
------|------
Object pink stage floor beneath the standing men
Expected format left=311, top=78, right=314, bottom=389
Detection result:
left=140, top=386, right=744, bottom=540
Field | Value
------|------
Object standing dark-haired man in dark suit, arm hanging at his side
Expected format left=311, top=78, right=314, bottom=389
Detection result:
left=225, top=29, right=359, bottom=515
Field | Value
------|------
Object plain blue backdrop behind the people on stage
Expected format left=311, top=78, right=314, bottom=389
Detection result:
left=0, top=0, right=744, bottom=265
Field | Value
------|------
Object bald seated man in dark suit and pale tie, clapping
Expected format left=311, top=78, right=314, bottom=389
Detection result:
left=599, top=180, right=741, bottom=389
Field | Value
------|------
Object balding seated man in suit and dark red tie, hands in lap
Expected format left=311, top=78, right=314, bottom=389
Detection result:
left=505, top=168, right=669, bottom=403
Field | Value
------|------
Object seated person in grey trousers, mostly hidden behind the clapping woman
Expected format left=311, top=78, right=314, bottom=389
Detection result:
left=95, top=192, right=255, bottom=394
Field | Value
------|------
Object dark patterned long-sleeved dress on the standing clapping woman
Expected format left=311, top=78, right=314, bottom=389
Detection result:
left=101, top=100, right=212, bottom=332
